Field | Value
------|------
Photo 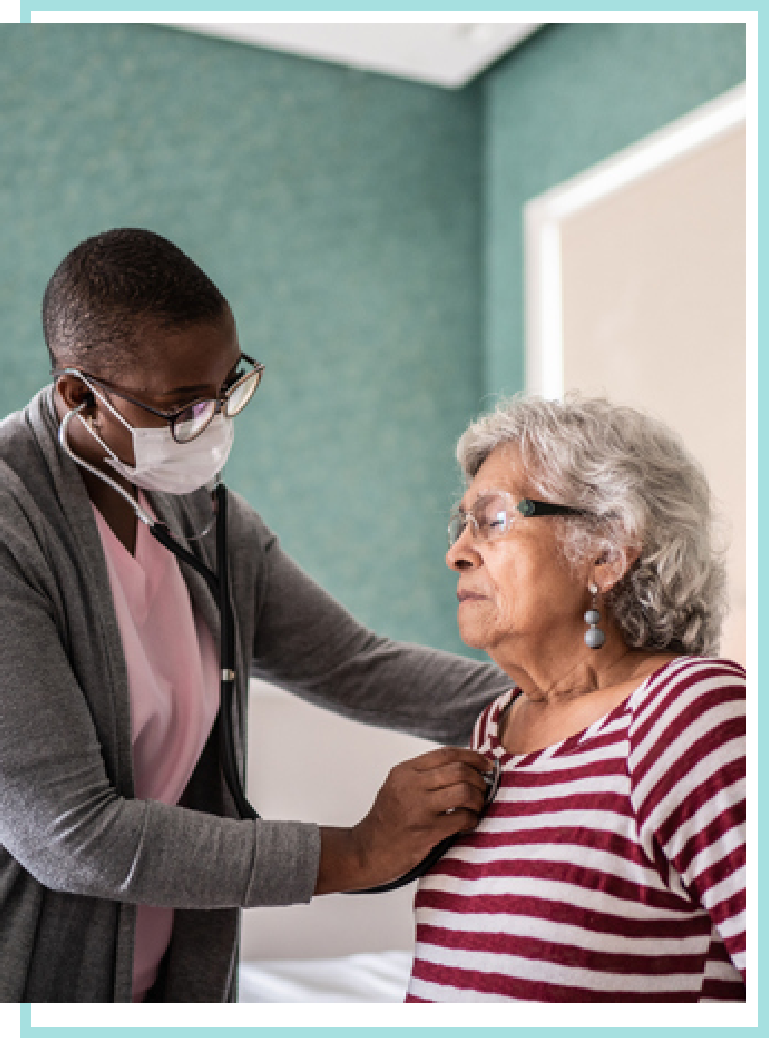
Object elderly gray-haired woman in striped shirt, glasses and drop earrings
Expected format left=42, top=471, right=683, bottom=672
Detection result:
left=407, top=395, right=745, bottom=1002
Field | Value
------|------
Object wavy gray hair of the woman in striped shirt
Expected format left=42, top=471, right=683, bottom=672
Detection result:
left=457, top=392, right=726, bottom=655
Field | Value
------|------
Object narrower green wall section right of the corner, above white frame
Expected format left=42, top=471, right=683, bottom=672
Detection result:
left=480, top=22, right=745, bottom=394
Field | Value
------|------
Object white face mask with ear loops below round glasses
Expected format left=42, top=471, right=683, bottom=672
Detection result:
left=73, top=375, right=235, bottom=494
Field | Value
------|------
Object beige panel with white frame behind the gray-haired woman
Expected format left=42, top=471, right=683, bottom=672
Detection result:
left=529, top=85, right=746, bottom=664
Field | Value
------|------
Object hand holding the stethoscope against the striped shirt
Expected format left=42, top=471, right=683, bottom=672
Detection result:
left=314, top=746, right=491, bottom=894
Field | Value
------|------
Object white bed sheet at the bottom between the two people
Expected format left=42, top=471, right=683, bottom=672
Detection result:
left=239, top=951, right=412, bottom=1002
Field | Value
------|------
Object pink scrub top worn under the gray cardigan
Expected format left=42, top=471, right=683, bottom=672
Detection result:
left=93, top=495, right=219, bottom=1002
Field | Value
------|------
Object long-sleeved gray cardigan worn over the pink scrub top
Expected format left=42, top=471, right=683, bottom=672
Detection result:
left=0, top=387, right=509, bottom=1002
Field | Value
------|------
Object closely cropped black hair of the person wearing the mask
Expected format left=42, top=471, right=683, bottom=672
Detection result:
left=42, top=227, right=229, bottom=374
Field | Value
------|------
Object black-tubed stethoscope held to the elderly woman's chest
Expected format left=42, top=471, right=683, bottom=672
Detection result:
left=59, top=404, right=500, bottom=894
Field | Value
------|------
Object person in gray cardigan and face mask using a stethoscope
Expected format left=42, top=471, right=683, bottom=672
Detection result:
left=0, top=229, right=509, bottom=1002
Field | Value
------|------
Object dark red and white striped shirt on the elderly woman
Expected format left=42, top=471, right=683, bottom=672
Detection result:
left=406, top=657, right=745, bottom=1002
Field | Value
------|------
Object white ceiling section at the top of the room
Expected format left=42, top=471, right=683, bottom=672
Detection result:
left=163, top=22, right=543, bottom=87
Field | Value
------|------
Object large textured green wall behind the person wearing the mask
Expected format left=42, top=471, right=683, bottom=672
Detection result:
left=0, top=25, right=483, bottom=650
